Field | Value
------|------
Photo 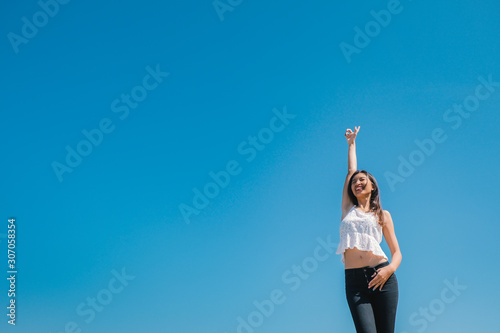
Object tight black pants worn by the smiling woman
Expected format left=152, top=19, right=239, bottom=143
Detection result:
left=345, top=261, right=399, bottom=333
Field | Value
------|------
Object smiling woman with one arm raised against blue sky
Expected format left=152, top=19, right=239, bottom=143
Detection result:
left=337, top=126, right=402, bottom=333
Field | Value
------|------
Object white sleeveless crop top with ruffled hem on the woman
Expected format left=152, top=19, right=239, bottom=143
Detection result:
left=336, top=205, right=387, bottom=264
